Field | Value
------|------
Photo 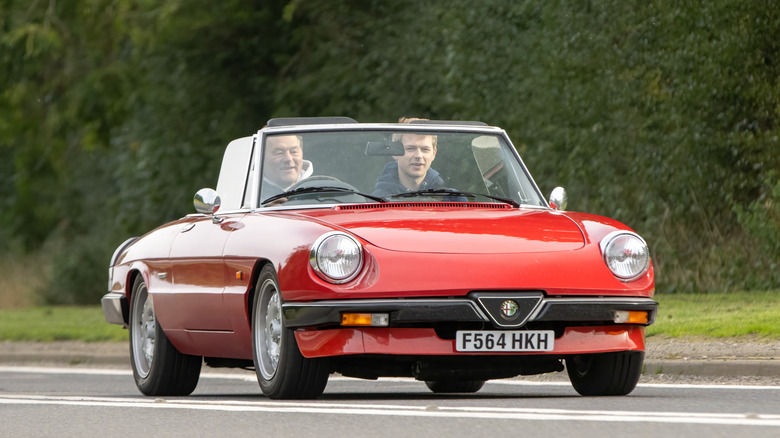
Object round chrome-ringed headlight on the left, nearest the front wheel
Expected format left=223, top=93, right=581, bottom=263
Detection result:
left=309, top=231, right=363, bottom=284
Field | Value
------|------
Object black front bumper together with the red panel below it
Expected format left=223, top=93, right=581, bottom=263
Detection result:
left=282, top=292, right=658, bottom=358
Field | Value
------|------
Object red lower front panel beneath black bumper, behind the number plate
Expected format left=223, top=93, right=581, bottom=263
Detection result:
left=295, top=326, right=645, bottom=358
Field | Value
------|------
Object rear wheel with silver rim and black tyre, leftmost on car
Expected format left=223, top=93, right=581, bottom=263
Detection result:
left=128, top=275, right=203, bottom=396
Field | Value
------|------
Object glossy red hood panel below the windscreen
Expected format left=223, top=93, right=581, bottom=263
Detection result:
left=298, top=208, right=585, bottom=254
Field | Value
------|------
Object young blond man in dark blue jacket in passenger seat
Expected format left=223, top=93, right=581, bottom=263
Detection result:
left=372, top=117, right=444, bottom=198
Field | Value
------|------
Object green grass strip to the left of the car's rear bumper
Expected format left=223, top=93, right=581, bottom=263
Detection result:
left=0, top=306, right=128, bottom=342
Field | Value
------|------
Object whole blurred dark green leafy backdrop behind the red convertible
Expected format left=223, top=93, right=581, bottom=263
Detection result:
left=0, top=0, right=780, bottom=305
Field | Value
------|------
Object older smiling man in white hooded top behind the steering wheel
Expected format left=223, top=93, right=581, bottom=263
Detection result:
left=263, top=135, right=314, bottom=198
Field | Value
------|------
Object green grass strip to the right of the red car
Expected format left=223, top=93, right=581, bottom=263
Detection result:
left=647, top=291, right=780, bottom=340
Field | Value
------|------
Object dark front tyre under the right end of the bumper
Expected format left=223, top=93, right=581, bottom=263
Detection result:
left=566, top=351, right=645, bottom=396
